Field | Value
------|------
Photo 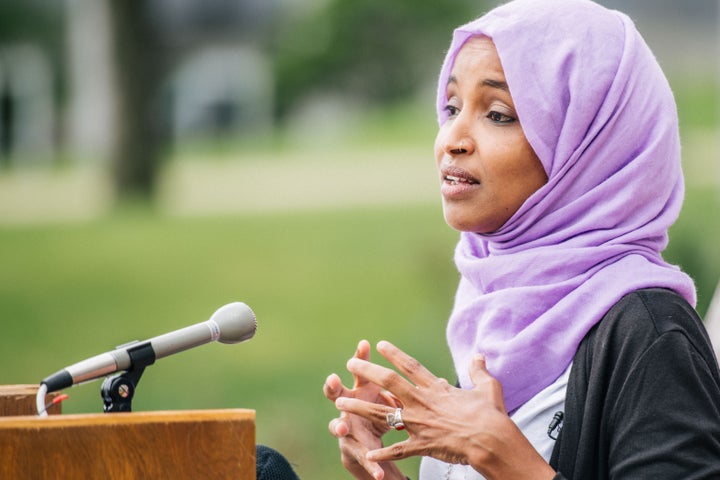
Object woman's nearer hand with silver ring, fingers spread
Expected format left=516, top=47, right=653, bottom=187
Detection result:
left=335, top=342, right=555, bottom=479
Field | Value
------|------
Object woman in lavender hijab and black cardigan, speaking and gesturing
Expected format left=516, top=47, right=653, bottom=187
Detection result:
left=324, top=0, right=720, bottom=480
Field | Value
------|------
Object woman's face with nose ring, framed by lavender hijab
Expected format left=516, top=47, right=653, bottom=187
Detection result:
left=435, top=37, right=547, bottom=233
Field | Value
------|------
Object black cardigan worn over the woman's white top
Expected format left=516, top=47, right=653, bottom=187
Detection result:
left=550, top=289, right=720, bottom=480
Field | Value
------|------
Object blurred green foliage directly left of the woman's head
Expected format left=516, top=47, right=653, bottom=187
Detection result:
left=274, top=0, right=489, bottom=117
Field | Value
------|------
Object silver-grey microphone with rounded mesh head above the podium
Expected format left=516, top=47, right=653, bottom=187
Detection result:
left=40, top=302, right=257, bottom=393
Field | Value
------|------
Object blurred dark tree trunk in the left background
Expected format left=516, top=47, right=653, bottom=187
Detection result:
left=110, top=0, right=168, bottom=200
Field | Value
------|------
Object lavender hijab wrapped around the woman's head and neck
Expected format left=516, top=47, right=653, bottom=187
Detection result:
left=437, top=0, right=695, bottom=411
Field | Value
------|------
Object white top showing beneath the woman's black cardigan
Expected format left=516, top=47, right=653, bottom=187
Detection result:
left=420, top=364, right=572, bottom=480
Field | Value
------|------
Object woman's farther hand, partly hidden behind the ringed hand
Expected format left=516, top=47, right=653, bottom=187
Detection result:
left=323, top=340, right=405, bottom=480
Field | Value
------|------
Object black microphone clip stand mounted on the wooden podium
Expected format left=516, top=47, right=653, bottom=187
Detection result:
left=100, top=342, right=155, bottom=413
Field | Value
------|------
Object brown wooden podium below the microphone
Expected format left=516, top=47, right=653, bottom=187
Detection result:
left=0, top=386, right=255, bottom=480
